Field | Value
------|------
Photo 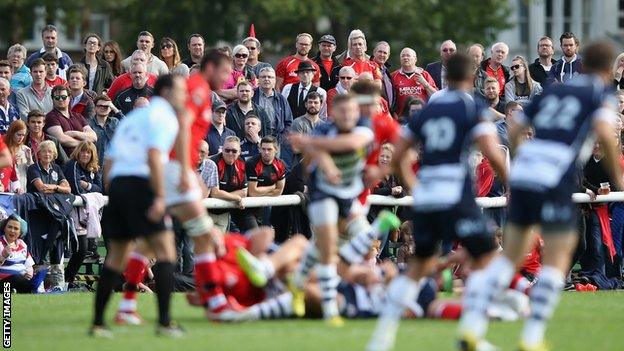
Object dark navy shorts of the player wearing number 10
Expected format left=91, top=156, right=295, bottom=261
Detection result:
left=413, top=201, right=496, bottom=258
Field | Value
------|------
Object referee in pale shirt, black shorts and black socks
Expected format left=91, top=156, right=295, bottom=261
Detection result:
left=90, top=75, right=187, bottom=338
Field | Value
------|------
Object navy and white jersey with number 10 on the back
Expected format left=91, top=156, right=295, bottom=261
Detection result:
left=403, top=90, right=496, bottom=211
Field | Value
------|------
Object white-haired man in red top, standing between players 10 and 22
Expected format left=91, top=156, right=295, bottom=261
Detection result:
left=475, top=42, right=510, bottom=98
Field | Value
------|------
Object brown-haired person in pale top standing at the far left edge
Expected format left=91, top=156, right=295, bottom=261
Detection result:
left=4, top=120, right=34, bottom=192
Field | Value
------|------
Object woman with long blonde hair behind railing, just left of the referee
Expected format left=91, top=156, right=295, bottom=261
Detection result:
left=63, top=141, right=103, bottom=195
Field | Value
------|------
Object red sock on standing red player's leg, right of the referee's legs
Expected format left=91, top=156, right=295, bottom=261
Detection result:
left=195, top=252, right=227, bottom=311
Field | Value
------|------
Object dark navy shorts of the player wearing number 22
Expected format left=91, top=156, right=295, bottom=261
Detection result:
left=509, top=187, right=577, bottom=234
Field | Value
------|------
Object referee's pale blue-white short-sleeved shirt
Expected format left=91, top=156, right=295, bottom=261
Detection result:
left=106, top=96, right=179, bottom=179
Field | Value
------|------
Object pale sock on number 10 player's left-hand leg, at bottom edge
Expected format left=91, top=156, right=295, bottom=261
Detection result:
left=367, top=275, right=424, bottom=350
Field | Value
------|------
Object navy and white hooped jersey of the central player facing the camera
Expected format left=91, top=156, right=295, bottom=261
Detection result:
left=310, top=119, right=373, bottom=199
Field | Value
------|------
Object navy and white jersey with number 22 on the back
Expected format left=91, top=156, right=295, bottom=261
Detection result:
left=510, top=75, right=617, bottom=191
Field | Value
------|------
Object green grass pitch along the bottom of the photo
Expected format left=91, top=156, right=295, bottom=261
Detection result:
left=7, top=292, right=624, bottom=351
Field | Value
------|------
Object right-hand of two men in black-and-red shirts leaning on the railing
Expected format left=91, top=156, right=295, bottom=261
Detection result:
left=245, top=136, right=286, bottom=196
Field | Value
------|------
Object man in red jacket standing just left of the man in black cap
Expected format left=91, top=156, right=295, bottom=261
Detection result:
left=275, top=33, right=321, bottom=91
